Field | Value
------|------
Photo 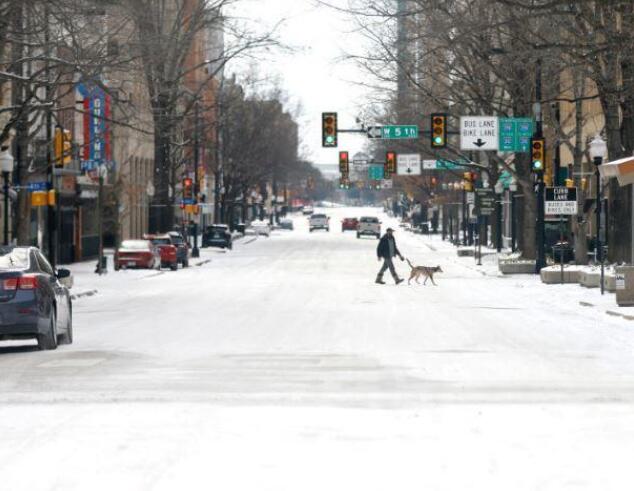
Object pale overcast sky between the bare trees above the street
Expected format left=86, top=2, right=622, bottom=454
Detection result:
left=229, top=0, right=367, bottom=173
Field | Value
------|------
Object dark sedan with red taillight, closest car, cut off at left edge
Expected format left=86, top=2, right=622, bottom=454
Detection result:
left=0, top=247, right=73, bottom=349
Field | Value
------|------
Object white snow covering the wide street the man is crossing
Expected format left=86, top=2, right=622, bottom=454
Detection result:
left=0, top=208, right=634, bottom=491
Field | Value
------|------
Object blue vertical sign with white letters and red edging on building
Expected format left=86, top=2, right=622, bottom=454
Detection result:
left=77, top=83, right=112, bottom=172
